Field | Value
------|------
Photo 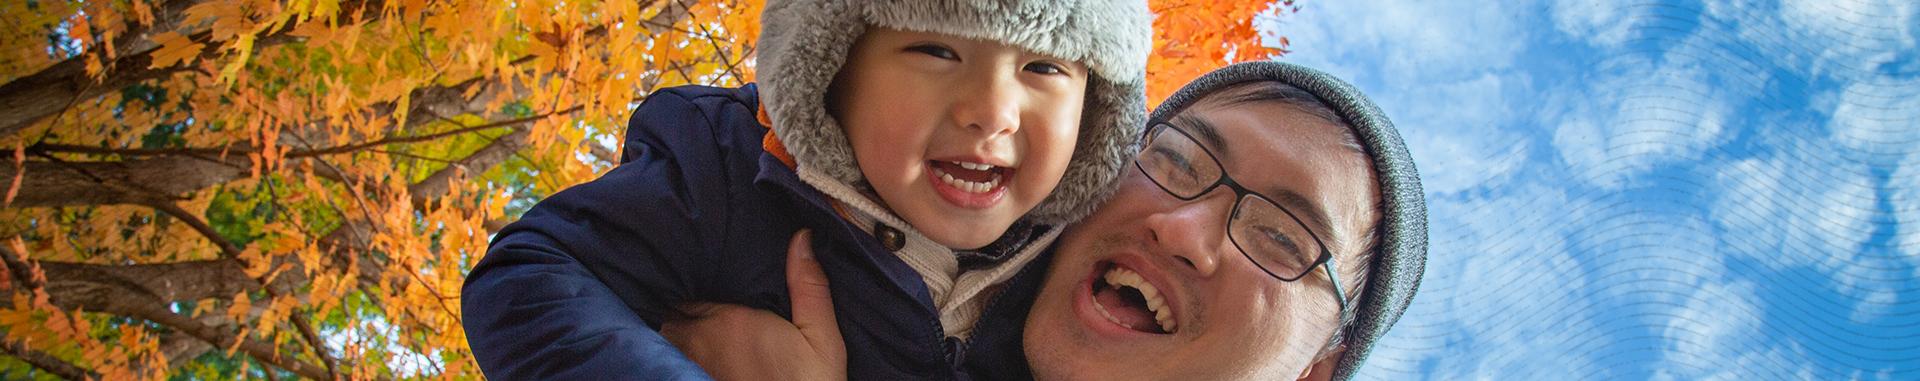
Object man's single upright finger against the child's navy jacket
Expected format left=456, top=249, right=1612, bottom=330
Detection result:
left=787, top=231, right=845, bottom=356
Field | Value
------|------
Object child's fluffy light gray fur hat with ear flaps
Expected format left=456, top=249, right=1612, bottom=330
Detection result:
left=756, top=0, right=1152, bottom=223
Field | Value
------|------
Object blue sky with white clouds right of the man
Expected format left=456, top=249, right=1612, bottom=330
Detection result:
left=1265, top=0, right=1920, bottom=379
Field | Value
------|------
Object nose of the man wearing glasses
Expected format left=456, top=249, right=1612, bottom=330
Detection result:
left=1146, top=191, right=1233, bottom=277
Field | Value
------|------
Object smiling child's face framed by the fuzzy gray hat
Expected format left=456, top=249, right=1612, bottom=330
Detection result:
left=829, top=29, right=1089, bottom=248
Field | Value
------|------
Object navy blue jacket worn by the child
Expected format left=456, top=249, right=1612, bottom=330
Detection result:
left=461, top=85, right=1050, bottom=379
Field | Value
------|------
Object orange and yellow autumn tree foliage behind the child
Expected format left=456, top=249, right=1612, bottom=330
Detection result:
left=0, top=0, right=1292, bottom=379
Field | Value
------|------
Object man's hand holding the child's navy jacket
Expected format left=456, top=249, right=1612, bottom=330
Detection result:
left=660, top=231, right=847, bottom=381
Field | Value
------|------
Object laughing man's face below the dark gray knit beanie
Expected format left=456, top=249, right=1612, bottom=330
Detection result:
left=1025, top=94, right=1379, bottom=379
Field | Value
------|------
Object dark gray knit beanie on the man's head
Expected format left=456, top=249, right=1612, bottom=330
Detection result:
left=1154, top=62, right=1427, bottom=381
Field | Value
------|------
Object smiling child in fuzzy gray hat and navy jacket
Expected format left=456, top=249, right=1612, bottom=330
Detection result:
left=461, top=0, right=1150, bottom=379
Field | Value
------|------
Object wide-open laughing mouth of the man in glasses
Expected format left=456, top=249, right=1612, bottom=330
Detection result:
left=1092, top=264, right=1179, bottom=335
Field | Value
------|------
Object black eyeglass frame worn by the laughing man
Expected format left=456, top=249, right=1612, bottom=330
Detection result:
left=1133, top=119, right=1348, bottom=311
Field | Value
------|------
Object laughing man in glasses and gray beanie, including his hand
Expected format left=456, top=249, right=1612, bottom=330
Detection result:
left=666, top=62, right=1427, bottom=379
